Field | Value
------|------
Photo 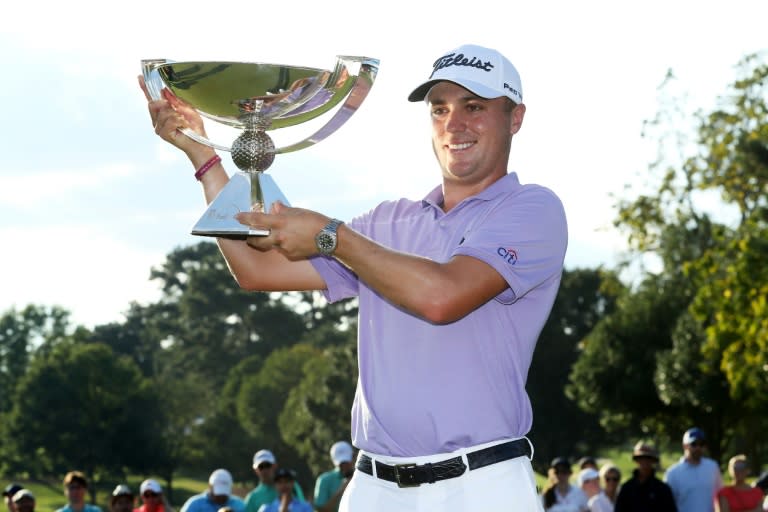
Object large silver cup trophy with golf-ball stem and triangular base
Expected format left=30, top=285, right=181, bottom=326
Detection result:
left=141, top=56, right=379, bottom=239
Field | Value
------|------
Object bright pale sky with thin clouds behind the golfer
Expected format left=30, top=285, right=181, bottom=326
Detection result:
left=0, top=0, right=768, bottom=327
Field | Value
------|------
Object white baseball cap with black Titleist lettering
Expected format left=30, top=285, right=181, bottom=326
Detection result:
left=408, top=44, right=523, bottom=103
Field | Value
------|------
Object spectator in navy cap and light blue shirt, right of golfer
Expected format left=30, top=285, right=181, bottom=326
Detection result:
left=664, top=427, right=723, bottom=512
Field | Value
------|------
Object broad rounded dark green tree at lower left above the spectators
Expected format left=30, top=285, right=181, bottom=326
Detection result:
left=7, top=342, right=162, bottom=500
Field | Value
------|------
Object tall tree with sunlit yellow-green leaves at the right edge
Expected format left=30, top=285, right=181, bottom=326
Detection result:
left=600, top=55, right=768, bottom=464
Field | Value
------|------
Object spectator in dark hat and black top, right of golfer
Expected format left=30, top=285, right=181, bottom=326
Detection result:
left=614, top=441, right=677, bottom=512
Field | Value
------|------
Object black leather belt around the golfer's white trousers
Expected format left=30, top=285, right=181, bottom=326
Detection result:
left=355, top=439, right=531, bottom=487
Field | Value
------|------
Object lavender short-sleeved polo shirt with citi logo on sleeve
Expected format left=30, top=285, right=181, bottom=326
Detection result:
left=312, top=173, right=568, bottom=457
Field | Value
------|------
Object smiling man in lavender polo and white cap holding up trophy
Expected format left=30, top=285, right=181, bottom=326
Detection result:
left=145, top=45, right=567, bottom=512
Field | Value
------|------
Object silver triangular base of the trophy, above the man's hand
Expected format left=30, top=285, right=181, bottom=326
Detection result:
left=191, top=171, right=290, bottom=240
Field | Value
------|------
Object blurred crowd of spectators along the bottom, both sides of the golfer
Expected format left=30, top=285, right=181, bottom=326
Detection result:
left=3, top=428, right=768, bottom=512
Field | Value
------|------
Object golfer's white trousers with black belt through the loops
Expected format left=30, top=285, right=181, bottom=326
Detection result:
left=339, top=440, right=543, bottom=512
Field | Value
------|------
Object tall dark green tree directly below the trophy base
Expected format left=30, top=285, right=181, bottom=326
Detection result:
left=151, top=242, right=305, bottom=392
